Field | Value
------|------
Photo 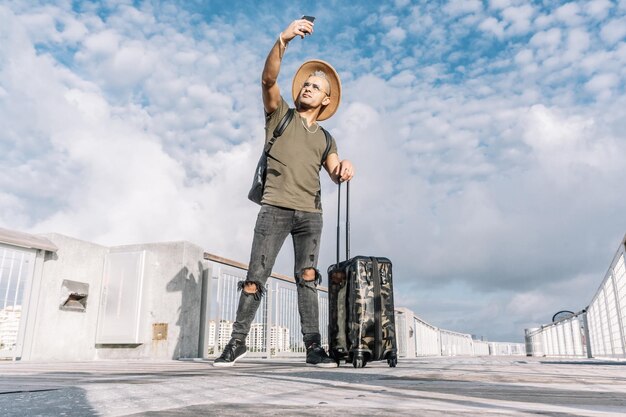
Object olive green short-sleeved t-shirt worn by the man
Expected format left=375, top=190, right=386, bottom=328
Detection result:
left=261, top=99, right=337, bottom=213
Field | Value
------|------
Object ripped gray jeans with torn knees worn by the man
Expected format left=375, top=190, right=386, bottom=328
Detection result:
left=232, top=205, right=322, bottom=346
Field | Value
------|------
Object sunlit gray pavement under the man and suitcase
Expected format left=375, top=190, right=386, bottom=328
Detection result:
left=0, top=356, right=626, bottom=417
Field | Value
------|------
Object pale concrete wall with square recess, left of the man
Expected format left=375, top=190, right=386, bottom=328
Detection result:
left=22, top=234, right=208, bottom=361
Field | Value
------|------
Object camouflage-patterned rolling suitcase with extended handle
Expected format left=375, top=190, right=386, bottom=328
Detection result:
left=328, top=183, right=398, bottom=368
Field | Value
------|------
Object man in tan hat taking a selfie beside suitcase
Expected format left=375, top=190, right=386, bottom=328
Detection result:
left=213, top=19, right=354, bottom=367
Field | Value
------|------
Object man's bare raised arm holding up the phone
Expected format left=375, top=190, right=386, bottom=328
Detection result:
left=261, top=19, right=313, bottom=114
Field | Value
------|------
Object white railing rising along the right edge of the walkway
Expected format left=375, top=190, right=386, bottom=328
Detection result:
left=526, top=237, right=626, bottom=359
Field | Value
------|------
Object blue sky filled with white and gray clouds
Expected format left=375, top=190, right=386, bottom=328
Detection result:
left=0, top=0, right=626, bottom=341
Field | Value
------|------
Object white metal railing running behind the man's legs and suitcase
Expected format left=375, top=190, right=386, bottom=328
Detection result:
left=205, top=254, right=525, bottom=358
